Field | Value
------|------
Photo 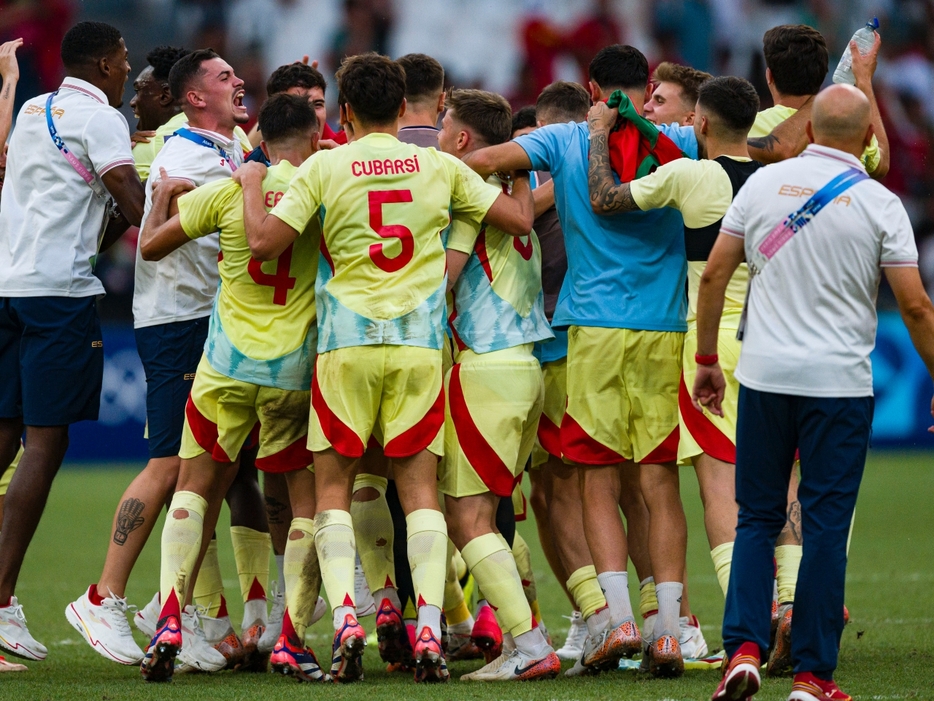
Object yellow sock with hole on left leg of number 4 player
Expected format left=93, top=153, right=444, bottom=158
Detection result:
left=159, top=492, right=208, bottom=608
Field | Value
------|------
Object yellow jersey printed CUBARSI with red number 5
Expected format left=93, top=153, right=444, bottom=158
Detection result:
left=272, top=133, right=499, bottom=353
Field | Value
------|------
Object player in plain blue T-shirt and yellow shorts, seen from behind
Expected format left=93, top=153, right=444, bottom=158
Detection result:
left=466, top=44, right=690, bottom=676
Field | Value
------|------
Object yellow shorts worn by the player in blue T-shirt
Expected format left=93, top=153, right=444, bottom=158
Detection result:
left=561, top=326, right=684, bottom=465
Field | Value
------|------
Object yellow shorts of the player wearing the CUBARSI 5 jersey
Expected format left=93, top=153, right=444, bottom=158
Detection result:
left=308, top=345, right=444, bottom=458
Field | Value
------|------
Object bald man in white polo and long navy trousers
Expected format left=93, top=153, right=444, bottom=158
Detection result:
left=693, top=85, right=934, bottom=701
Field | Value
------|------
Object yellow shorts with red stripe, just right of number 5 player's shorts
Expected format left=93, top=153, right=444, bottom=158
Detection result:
left=440, top=343, right=545, bottom=498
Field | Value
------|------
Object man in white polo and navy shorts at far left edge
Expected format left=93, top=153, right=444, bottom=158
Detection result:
left=0, top=22, right=144, bottom=659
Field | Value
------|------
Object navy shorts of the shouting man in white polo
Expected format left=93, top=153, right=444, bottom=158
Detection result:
left=136, top=317, right=208, bottom=458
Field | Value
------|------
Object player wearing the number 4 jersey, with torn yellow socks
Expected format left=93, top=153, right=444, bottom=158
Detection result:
left=140, top=94, right=325, bottom=681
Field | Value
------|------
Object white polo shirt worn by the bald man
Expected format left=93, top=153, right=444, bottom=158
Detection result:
left=721, top=144, right=918, bottom=397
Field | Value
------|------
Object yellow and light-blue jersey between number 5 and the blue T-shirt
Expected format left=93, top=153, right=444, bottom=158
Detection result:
left=448, top=175, right=554, bottom=353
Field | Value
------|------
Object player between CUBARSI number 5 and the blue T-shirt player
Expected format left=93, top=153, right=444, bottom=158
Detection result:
left=438, top=90, right=561, bottom=681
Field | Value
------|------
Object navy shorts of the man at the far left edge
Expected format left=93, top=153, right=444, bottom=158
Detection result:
left=0, top=297, right=104, bottom=426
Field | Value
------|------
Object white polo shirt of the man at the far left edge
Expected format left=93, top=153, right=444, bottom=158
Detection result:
left=0, top=77, right=133, bottom=297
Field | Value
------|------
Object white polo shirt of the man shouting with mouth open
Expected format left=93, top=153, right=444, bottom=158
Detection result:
left=133, top=126, right=243, bottom=328
